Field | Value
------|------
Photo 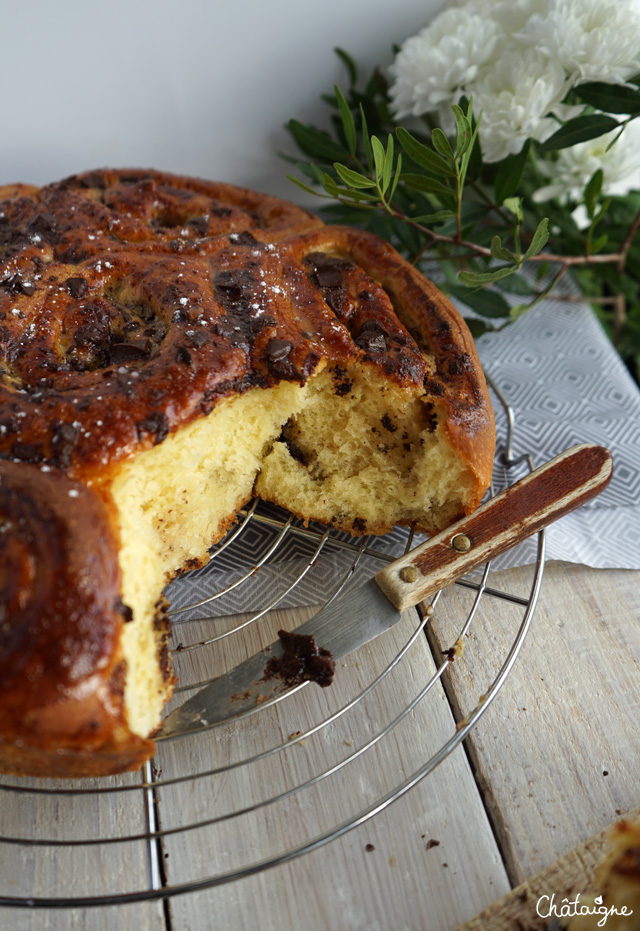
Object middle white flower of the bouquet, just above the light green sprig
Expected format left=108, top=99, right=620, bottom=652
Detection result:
left=473, top=43, right=567, bottom=162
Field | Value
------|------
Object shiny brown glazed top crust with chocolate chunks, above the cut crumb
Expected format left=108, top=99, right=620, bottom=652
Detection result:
left=0, top=170, right=491, bottom=483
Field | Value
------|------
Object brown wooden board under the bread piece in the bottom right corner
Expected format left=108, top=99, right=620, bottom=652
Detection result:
left=458, top=807, right=640, bottom=931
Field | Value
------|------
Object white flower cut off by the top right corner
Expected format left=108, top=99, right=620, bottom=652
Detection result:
left=516, top=0, right=640, bottom=84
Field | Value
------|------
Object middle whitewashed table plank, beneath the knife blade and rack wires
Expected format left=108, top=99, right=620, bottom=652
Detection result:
left=158, top=596, right=509, bottom=931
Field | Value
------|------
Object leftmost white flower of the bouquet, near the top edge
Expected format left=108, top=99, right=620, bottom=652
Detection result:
left=390, top=7, right=501, bottom=129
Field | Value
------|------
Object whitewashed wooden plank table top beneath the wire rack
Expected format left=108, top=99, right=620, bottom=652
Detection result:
left=0, top=563, right=640, bottom=931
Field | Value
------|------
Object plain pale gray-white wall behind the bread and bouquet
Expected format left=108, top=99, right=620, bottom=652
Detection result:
left=0, top=0, right=444, bottom=200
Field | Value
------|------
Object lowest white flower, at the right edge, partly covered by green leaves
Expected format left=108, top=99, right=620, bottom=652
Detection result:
left=534, top=120, right=640, bottom=204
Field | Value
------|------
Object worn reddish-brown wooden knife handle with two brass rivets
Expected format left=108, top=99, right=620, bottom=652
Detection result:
left=376, top=445, right=613, bottom=611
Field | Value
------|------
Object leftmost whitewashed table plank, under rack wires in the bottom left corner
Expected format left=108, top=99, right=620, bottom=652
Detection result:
left=0, top=774, right=165, bottom=931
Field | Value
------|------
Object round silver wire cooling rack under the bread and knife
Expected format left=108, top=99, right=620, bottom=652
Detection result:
left=0, top=385, right=544, bottom=908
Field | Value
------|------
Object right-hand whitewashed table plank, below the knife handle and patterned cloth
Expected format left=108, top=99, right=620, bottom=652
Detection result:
left=430, top=563, right=640, bottom=885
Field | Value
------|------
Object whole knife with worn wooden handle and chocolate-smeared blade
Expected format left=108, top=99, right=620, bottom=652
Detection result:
left=154, top=444, right=613, bottom=740
